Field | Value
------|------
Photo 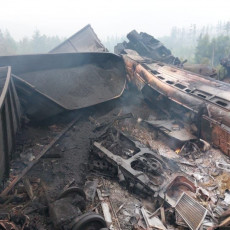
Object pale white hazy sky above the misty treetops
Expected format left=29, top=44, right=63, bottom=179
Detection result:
left=0, top=0, right=230, bottom=39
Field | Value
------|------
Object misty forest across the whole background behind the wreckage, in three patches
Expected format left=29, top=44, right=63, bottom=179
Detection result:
left=0, top=21, right=230, bottom=68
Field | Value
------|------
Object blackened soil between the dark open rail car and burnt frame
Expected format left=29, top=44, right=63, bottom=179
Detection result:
left=4, top=87, right=157, bottom=230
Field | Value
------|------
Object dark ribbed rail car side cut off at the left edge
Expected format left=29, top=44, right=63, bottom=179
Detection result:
left=0, top=67, right=20, bottom=181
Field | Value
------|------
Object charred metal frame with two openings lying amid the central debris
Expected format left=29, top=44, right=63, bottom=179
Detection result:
left=90, top=127, right=201, bottom=207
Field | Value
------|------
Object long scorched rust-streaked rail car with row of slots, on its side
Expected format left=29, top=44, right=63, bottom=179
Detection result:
left=123, top=54, right=230, bottom=156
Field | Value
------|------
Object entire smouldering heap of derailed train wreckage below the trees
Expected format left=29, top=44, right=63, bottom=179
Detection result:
left=0, top=26, right=230, bottom=230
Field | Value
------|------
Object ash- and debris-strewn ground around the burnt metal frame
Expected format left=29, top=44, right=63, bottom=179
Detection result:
left=1, top=90, right=230, bottom=230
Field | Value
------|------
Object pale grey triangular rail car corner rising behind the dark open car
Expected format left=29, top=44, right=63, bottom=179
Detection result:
left=49, top=25, right=107, bottom=53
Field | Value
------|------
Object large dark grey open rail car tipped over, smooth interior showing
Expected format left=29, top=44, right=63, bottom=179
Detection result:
left=0, top=53, right=126, bottom=121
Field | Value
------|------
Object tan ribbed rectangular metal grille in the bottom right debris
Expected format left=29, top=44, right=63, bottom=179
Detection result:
left=175, top=193, right=207, bottom=230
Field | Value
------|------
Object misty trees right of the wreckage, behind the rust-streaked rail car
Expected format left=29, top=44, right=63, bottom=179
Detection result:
left=159, top=21, right=230, bottom=68
